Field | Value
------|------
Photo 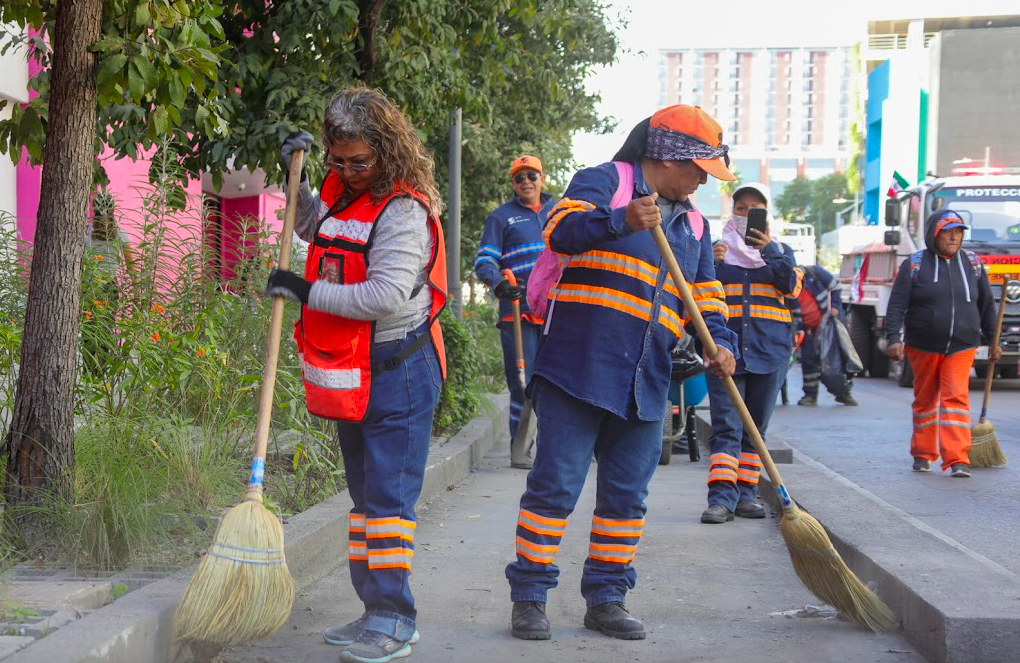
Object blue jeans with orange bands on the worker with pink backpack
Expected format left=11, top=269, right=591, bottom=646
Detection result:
left=506, top=377, right=665, bottom=607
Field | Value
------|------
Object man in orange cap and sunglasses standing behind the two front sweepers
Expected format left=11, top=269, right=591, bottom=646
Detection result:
left=474, top=155, right=551, bottom=459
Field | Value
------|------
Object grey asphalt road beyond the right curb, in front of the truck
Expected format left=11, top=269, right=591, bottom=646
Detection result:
left=768, top=366, right=1020, bottom=574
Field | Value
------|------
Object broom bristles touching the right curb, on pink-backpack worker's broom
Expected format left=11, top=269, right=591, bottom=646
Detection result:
left=779, top=509, right=899, bottom=632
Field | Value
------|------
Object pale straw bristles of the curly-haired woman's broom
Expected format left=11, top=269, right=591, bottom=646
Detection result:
left=174, top=500, right=294, bottom=647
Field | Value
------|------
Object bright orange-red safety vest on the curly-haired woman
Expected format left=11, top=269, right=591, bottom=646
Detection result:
left=294, top=172, right=447, bottom=421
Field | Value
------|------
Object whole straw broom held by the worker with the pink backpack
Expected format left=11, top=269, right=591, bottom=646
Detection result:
left=652, top=225, right=897, bottom=631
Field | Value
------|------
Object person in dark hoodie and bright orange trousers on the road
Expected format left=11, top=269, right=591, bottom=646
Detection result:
left=885, top=209, right=1003, bottom=477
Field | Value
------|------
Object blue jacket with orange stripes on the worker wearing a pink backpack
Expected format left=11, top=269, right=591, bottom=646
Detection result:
left=534, top=163, right=736, bottom=421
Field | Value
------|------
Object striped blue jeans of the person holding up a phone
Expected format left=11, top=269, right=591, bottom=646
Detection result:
left=708, top=367, right=786, bottom=511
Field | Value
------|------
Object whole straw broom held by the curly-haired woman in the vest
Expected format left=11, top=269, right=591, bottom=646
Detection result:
left=173, top=150, right=304, bottom=647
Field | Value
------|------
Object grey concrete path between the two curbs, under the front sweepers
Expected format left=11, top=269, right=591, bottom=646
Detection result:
left=216, top=444, right=924, bottom=663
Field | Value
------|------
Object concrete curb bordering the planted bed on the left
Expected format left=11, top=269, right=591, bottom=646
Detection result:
left=5, top=392, right=510, bottom=663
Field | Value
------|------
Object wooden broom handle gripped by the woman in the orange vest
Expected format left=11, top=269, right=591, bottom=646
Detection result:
left=249, top=150, right=305, bottom=489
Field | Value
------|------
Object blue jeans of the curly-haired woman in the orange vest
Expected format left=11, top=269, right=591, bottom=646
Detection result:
left=337, top=325, right=443, bottom=642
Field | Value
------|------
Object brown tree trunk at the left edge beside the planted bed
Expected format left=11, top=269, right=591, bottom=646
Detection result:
left=4, top=0, right=102, bottom=547
